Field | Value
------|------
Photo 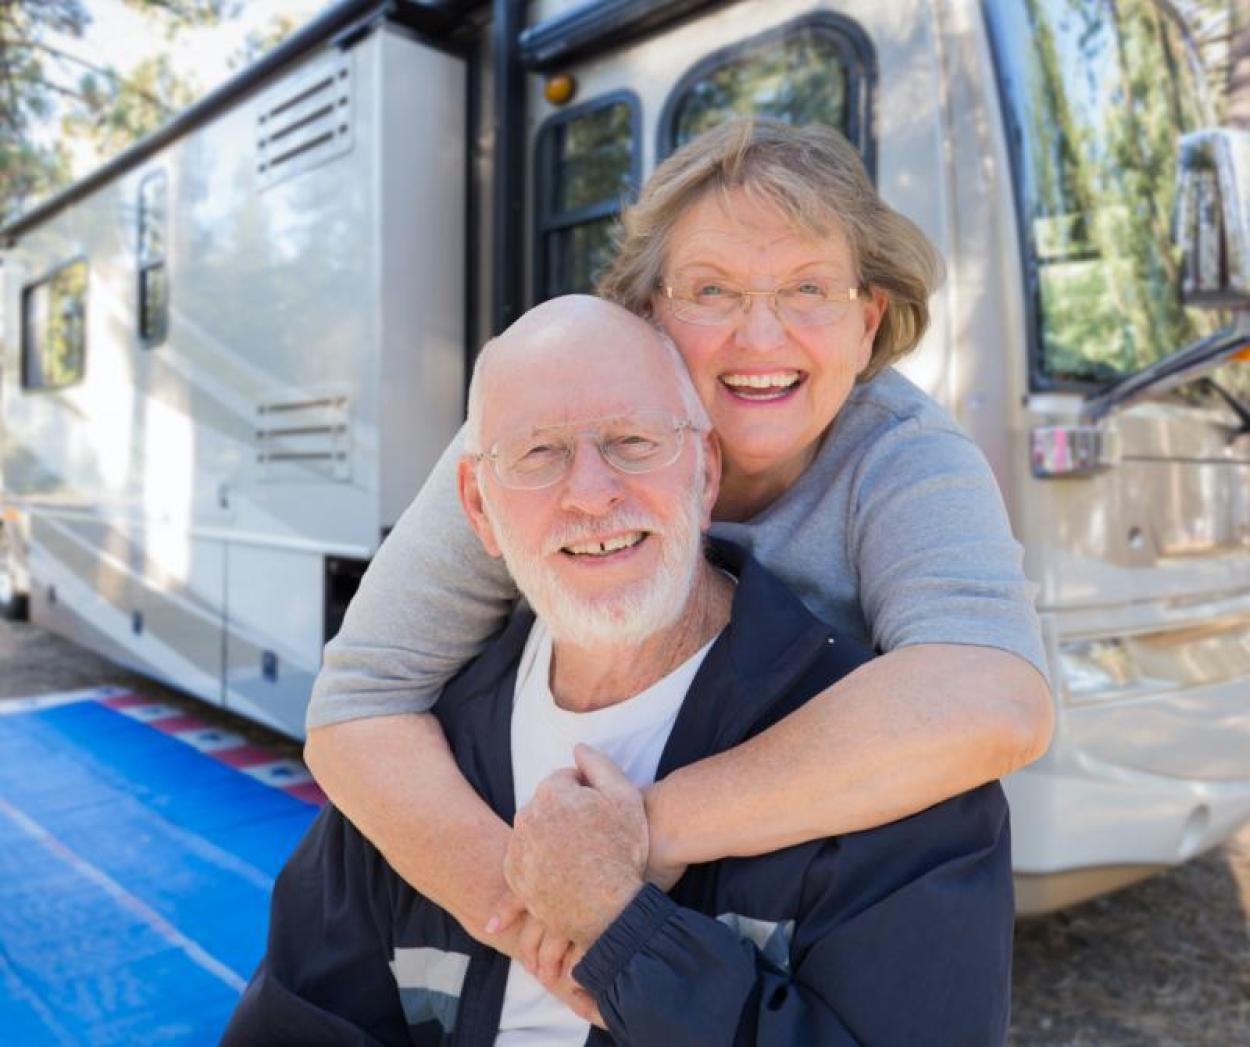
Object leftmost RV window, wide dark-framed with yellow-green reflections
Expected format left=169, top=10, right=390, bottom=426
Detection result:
left=21, top=260, right=86, bottom=389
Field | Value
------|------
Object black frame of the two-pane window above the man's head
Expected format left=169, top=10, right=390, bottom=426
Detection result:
left=531, top=87, right=643, bottom=304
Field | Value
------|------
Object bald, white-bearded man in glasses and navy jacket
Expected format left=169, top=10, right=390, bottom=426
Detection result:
left=224, top=297, right=1011, bottom=1047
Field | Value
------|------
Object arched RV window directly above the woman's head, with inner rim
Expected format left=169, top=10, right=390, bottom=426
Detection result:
left=660, top=15, right=873, bottom=162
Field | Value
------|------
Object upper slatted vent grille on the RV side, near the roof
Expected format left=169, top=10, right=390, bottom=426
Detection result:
left=256, top=51, right=354, bottom=189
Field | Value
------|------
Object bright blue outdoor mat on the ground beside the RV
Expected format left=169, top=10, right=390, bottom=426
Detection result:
left=0, top=701, right=318, bottom=1047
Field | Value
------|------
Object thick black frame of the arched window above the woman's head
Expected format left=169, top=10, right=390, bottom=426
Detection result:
left=655, top=11, right=878, bottom=178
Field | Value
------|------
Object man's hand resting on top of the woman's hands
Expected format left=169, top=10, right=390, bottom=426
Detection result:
left=504, top=745, right=649, bottom=950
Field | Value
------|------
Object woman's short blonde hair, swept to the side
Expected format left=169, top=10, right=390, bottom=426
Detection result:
left=596, top=117, right=944, bottom=381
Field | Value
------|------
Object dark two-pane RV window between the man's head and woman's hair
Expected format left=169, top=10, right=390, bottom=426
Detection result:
left=535, top=91, right=639, bottom=301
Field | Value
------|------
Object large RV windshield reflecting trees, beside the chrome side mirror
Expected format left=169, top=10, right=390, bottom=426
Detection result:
left=985, top=0, right=1223, bottom=385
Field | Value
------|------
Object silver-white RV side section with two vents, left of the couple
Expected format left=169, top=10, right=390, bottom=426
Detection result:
left=3, top=26, right=466, bottom=735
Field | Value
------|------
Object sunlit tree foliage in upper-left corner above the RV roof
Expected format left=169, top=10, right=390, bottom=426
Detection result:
left=0, top=0, right=243, bottom=224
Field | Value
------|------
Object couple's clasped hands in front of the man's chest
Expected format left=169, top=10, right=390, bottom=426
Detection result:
left=486, top=745, right=684, bottom=1026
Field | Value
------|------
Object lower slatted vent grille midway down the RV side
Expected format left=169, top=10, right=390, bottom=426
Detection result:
left=256, top=394, right=351, bottom=482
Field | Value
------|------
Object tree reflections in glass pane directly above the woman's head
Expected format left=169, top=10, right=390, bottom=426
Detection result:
left=674, top=26, right=846, bottom=145
